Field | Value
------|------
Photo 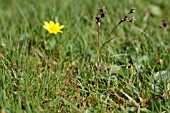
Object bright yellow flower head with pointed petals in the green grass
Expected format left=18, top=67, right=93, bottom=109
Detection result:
left=43, top=21, right=64, bottom=34
